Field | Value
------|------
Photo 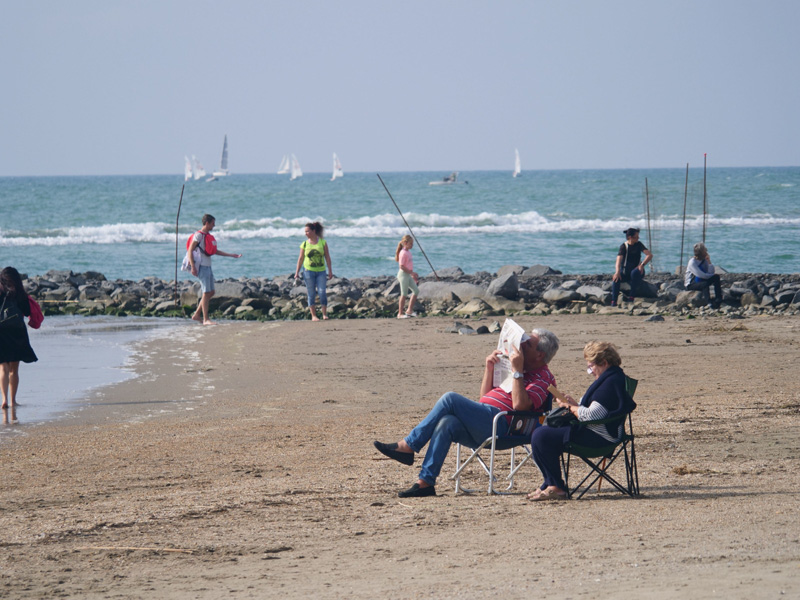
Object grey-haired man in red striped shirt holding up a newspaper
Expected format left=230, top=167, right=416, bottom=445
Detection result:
left=373, top=329, right=559, bottom=498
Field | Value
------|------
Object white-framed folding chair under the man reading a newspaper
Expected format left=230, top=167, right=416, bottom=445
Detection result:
left=450, top=394, right=553, bottom=495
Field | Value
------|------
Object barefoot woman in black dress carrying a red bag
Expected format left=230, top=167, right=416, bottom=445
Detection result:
left=0, top=267, right=38, bottom=408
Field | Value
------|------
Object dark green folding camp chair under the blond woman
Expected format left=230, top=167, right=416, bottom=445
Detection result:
left=561, top=376, right=639, bottom=499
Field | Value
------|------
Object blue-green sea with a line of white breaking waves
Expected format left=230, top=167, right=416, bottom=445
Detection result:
left=0, top=166, right=800, bottom=281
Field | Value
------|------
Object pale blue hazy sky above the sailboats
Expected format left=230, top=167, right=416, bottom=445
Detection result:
left=0, top=0, right=800, bottom=176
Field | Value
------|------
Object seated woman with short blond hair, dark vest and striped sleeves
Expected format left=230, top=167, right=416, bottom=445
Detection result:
left=528, top=342, right=636, bottom=500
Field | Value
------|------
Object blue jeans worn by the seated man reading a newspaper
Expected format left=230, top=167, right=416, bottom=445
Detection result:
left=405, top=392, right=508, bottom=485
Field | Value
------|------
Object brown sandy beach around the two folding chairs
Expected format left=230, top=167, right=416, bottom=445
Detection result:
left=0, top=314, right=800, bottom=599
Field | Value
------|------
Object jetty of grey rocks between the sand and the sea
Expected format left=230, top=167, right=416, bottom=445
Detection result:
left=25, top=265, right=800, bottom=321
